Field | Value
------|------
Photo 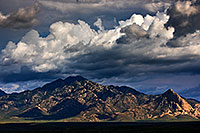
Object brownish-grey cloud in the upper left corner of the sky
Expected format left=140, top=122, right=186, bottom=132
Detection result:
left=0, top=3, right=40, bottom=29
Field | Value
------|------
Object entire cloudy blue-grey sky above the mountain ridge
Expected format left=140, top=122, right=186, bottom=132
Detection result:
left=0, top=0, right=200, bottom=100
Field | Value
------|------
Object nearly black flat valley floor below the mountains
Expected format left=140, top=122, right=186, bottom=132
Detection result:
left=0, top=121, right=200, bottom=133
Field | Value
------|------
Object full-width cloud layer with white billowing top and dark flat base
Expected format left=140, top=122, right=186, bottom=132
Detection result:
left=0, top=8, right=200, bottom=85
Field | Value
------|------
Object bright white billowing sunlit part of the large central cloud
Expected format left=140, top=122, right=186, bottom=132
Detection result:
left=1, top=10, right=173, bottom=72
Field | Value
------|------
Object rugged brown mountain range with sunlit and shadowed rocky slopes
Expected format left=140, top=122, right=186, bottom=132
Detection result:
left=0, top=76, right=200, bottom=121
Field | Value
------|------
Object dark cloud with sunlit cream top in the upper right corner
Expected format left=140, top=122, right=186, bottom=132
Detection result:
left=167, top=0, right=200, bottom=37
